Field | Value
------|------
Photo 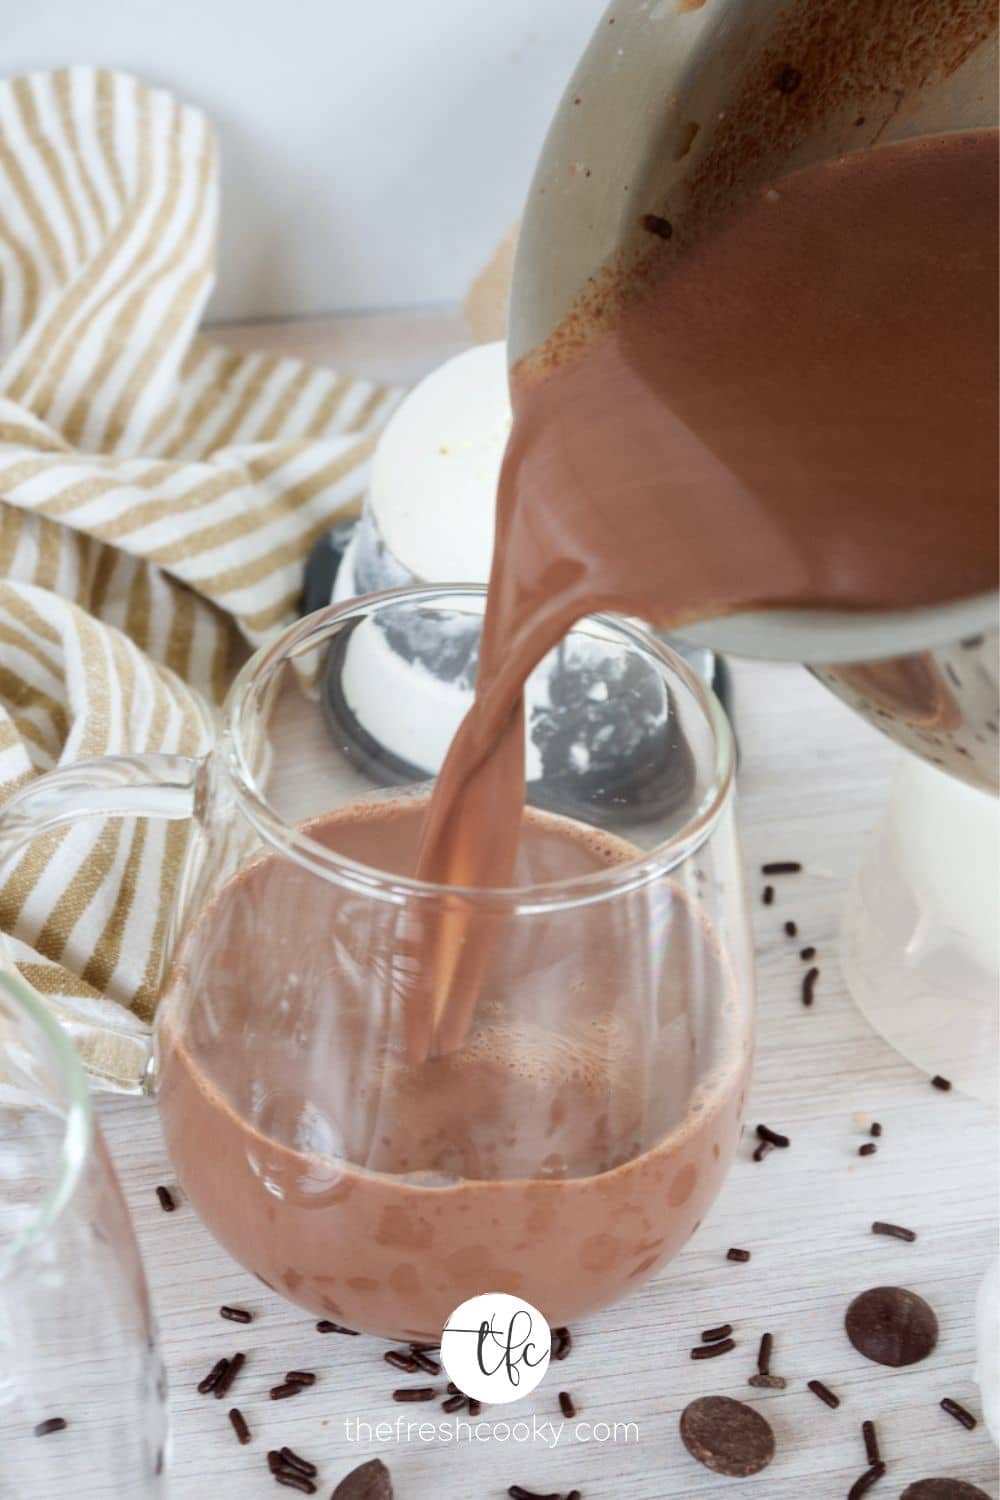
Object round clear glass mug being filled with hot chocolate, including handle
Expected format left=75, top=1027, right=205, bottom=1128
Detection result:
left=0, top=587, right=753, bottom=1340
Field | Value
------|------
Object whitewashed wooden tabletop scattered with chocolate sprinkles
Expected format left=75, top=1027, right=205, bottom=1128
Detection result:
left=95, top=315, right=997, bottom=1500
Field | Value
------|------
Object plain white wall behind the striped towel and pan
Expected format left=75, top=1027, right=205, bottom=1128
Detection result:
left=0, top=0, right=604, bottom=318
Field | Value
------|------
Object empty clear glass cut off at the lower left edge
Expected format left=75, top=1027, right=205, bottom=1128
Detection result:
left=0, top=956, right=166, bottom=1500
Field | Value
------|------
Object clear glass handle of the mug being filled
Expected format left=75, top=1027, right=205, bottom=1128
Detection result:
left=0, top=755, right=205, bottom=1094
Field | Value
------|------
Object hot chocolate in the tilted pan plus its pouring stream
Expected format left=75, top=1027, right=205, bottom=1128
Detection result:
left=409, top=131, right=997, bottom=1053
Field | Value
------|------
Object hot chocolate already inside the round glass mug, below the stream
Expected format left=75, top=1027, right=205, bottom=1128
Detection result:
left=159, top=798, right=750, bottom=1338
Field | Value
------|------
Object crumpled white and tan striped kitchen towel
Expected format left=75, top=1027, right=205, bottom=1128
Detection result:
left=0, top=68, right=396, bottom=1083
